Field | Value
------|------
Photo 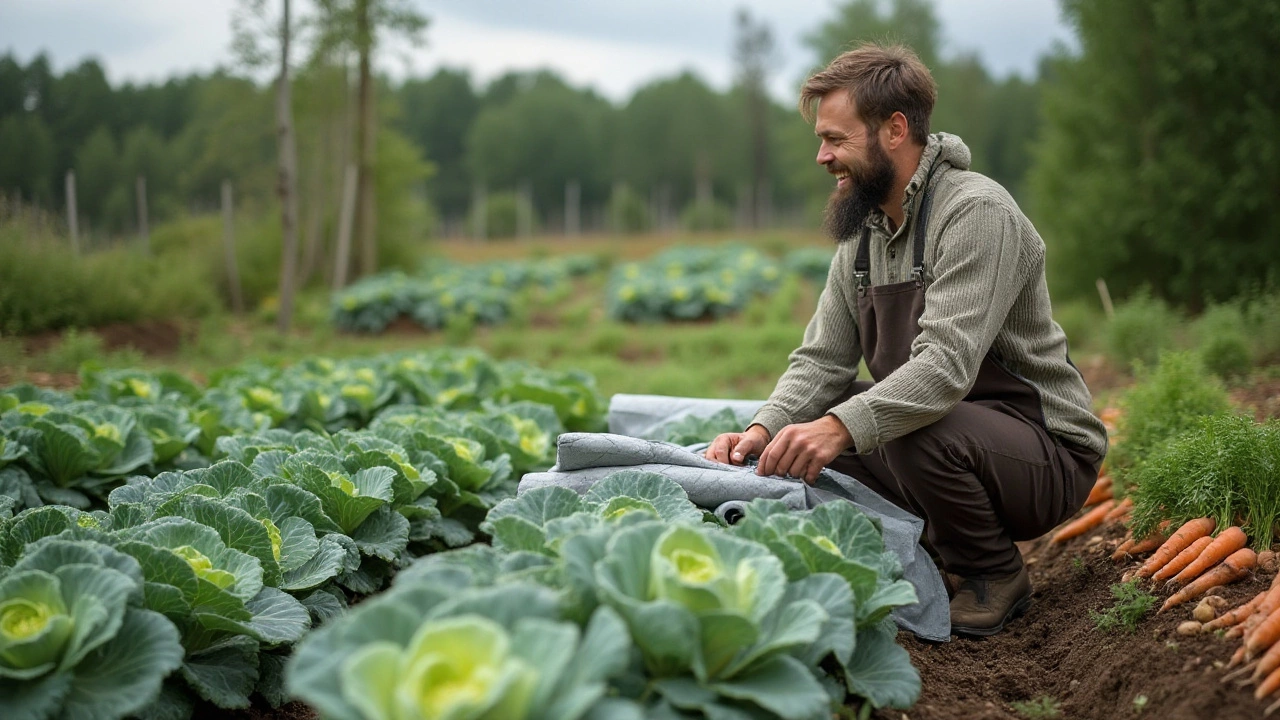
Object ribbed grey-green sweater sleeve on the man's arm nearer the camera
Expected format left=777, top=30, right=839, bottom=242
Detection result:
left=831, top=199, right=1032, bottom=452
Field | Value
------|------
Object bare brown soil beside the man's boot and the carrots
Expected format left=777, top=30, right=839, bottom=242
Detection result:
left=874, top=530, right=1271, bottom=720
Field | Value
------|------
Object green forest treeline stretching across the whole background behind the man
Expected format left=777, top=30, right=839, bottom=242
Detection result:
left=0, top=0, right=1280, bottom=305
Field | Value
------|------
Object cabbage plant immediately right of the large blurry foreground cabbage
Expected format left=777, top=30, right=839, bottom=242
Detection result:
left=595, top=523, right=831, bottom=719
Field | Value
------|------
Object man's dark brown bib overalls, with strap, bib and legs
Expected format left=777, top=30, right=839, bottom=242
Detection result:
left=831, top=184, right=1101, bottom=577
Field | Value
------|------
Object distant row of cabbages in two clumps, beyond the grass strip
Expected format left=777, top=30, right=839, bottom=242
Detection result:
left=332, top=243, right=832, bottom=333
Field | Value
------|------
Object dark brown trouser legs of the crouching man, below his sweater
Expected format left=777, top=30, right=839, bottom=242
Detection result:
left=831, top=382, right=1101, bottom=578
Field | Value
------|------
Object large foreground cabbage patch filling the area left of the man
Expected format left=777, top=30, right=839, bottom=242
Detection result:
left=0, top=352, right=919, bottom=720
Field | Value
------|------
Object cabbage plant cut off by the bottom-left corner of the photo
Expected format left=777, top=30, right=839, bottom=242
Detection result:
left=0, top=539, right=183, bottom=720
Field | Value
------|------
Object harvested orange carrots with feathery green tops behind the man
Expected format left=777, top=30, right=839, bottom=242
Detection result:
left=1055, top=352, right=1280, bottom=706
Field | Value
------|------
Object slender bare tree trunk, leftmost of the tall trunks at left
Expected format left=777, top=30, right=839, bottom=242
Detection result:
left=275, top=0, right=298, bottom=334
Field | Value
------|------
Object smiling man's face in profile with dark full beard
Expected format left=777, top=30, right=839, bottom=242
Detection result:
left=814, top=92, right=895, bottom=242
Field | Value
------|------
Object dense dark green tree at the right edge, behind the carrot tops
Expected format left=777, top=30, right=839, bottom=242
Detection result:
left=1030, top=0, right=1280, bottom=302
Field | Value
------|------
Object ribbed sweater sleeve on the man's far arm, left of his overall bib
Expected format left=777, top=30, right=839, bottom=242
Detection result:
left=751, top=242, right=863, bottom=438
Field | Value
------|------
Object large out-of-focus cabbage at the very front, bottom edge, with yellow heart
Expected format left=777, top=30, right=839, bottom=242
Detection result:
left=287, top=571, right=631, bottom=720
